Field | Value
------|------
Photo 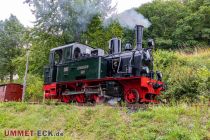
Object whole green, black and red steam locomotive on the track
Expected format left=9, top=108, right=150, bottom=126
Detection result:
left=43, top=25, right=164, bottom=104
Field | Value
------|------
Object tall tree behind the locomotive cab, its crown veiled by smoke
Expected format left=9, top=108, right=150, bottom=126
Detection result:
left=15, top=0, right=114, bottom=76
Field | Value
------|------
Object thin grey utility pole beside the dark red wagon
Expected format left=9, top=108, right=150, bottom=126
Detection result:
left=22, top=45, right=29, bottom=102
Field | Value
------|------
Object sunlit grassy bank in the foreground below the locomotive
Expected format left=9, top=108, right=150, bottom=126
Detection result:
left=0, top=103, right=210, bottom=140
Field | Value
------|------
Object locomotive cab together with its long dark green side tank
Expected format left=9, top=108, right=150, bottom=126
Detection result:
left=44, top=43, right=106, bottom=83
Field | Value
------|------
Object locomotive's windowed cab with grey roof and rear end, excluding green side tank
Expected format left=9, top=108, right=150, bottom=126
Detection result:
left=44, top=43, right=93, bottom=83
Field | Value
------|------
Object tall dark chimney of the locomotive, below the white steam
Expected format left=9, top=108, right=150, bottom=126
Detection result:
left=135, top=25, right=144, bottom=50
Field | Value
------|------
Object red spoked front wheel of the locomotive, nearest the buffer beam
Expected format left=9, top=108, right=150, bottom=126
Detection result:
left=125, top=89, right=139, bottom=104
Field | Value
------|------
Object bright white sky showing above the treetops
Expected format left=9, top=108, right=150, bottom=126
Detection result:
left=0, top=0, right=152, bottom=27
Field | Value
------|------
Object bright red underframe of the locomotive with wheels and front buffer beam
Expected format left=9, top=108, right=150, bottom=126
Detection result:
left=43, top=76, right=164, bottom=104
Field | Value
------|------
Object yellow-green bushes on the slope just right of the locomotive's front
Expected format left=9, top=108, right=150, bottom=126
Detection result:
left=154, top=50, right=210, bottom=102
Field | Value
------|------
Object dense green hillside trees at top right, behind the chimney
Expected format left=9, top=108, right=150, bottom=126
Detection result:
left=138, top=0, right=210, bottom=48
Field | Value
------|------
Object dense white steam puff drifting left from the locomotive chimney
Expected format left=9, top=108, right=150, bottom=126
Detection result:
left=104, top=9, right=151, bottom=29
